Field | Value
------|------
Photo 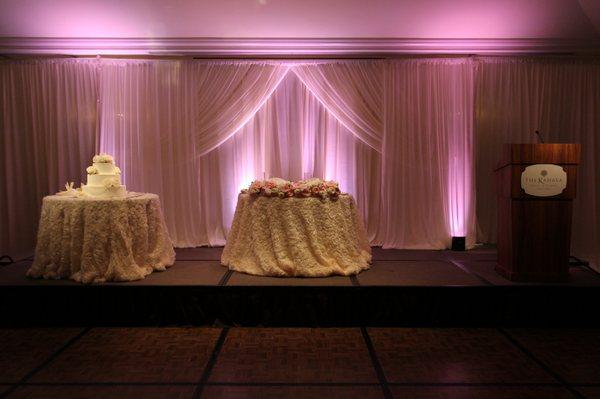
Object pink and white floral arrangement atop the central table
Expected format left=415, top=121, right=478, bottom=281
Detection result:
left=242, top=178, right=340, bottom=199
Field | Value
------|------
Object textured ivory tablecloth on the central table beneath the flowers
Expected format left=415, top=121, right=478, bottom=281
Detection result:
left=221, top=194, right=371, bottom=277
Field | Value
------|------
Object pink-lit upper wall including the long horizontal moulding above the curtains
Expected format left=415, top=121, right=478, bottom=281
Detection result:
left=0, top=0, right=600, bottom=57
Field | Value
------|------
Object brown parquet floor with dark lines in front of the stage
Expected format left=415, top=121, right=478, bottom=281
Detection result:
left=0, top=327, right=600, bottom=399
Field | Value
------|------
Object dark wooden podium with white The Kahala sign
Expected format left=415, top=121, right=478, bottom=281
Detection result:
left=495, top=144, right=581, bottom=282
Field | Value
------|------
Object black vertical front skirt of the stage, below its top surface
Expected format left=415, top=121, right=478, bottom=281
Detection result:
left=0, top=285, right=600, bottom=327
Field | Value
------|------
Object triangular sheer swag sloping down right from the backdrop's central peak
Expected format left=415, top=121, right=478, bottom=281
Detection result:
left=292, top=61, right=383, bottom=152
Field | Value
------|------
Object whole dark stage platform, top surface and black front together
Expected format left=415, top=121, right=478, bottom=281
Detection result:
left=0, top=247, right=600, bottom=327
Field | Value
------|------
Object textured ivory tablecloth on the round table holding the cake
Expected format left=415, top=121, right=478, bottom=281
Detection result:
left=27, top=194, right=175, bottom=283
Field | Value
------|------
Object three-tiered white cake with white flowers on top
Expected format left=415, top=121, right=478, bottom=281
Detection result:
left=81, top=154, right=127, bottom=198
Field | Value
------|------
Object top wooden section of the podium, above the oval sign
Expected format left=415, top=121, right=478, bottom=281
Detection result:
left=497, top=143, right=581, bottom=169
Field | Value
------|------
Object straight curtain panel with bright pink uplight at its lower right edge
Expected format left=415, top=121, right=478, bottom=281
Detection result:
left=380, top=59, right=475, bottom=249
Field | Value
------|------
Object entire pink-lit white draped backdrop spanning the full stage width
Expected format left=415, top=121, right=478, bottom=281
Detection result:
left=0, top=57, right=600, bottom=272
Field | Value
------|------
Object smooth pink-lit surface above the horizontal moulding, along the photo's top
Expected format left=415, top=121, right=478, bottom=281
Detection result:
left=0, top=0, right=600, bottom=53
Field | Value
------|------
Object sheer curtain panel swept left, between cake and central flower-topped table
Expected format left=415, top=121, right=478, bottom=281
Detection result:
left=100, top=60, right=287, bottom=247
